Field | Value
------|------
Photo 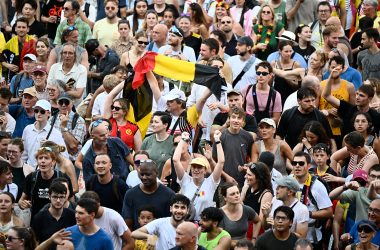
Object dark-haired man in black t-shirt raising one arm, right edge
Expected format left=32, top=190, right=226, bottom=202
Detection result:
left=322, top=63, right=380, bottom=135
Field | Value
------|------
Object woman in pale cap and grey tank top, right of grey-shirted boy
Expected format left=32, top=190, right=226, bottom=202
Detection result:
left=253, top=118, right=293, bottom=175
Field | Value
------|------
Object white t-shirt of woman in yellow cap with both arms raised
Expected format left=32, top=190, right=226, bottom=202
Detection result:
left=177, top=173, right=220, bottom=220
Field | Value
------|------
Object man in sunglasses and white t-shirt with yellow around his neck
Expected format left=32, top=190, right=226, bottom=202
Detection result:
left=291, top=151, right=333, bottom=249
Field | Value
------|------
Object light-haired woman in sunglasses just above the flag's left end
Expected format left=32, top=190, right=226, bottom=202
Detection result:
left=120, top=31, right=149, bottom=72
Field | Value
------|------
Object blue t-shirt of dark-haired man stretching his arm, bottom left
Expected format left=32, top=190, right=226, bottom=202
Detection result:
left=66, top=225, right=114, bottom=250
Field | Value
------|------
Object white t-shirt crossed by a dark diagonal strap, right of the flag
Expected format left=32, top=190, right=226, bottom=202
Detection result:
left=227, top=55, right=261, bottom=90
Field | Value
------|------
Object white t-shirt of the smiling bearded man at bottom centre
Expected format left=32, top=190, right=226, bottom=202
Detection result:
left=145, top=217, right=175, bottom=249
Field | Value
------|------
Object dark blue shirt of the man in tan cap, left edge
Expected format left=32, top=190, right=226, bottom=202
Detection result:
left=9, top=105, right=36, bottom=138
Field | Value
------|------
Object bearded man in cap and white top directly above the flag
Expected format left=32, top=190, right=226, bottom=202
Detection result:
left=158, top=25, right=197, bottom=63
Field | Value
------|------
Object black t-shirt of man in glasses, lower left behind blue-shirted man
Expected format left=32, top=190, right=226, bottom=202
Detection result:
left=31, top=208, right=76, bottom=245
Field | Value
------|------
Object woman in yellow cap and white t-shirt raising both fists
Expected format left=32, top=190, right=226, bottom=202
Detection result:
left=173, top=130, right=224, bottom=220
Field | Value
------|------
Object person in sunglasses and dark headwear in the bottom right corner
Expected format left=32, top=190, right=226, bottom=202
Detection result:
left=345, top=220, right=380, bottom=250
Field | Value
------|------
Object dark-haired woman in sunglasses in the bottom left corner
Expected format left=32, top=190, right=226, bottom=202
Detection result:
left=5, top=226, right=37, bottom=250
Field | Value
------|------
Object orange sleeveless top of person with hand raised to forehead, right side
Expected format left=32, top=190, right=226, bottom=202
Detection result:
left=319, top=79, right=350, bottom=135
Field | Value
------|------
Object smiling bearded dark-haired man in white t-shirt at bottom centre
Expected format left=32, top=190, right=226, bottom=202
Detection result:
left=132, top=194, right=190, bottom=249
